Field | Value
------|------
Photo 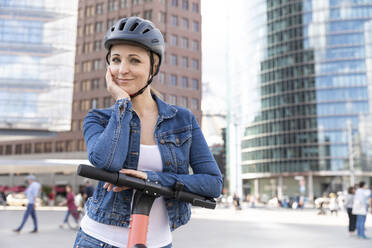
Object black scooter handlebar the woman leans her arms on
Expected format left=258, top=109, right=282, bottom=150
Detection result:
left=77, top=164, right=216, bottom=209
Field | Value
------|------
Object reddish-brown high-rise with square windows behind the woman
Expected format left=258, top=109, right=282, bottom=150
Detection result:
left=0, top=0, right=202, bottom=156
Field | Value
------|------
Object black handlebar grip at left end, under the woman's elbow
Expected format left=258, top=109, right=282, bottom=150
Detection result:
left=77, top=164, right=118, bottom=184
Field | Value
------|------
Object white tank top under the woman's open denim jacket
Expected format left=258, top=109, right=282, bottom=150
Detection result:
left=80, top=144, right=172, bottom=248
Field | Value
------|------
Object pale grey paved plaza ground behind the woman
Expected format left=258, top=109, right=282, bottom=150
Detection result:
left=0, top=205, right=372, bottom=248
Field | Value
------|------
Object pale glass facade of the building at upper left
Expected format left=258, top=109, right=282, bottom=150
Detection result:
left=0, top=0, right=77, bottom=131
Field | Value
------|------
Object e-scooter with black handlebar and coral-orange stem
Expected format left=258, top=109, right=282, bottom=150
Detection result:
left=78, top=164, right=216, bottom=248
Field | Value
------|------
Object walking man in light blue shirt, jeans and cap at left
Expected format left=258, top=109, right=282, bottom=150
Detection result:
left=13, top=175, right=41, bottom=233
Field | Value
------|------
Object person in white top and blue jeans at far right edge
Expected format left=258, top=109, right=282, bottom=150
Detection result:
left=352, top=181, right=371, bottom=239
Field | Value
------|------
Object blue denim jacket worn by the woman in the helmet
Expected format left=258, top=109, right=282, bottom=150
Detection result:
left=83, top=96, right=222, bottom=230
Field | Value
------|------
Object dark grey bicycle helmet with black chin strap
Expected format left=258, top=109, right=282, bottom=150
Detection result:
left=104, top=16, right=164, bottom=98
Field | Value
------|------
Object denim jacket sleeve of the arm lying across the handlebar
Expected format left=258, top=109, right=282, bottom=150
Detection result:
left=146, top=114, right=222, bottom=198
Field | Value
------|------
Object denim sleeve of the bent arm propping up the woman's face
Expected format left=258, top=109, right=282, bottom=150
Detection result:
left=83, top=99, right=132, bottom=171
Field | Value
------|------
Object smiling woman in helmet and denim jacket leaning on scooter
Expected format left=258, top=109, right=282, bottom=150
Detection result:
left=74, top=17, right=222, bottom=247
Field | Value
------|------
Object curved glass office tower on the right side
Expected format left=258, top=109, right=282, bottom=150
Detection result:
left=230, top=0, right=372, bottom=198
